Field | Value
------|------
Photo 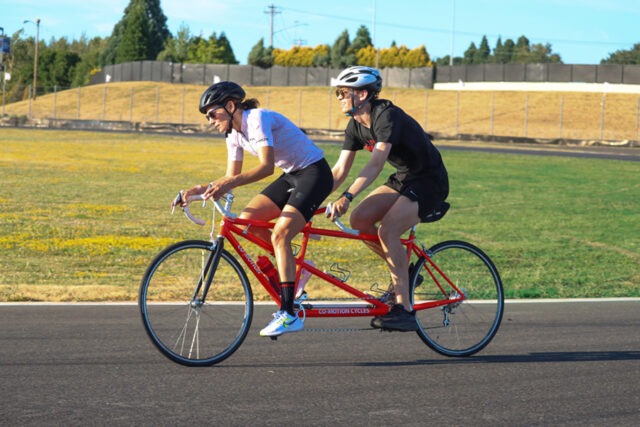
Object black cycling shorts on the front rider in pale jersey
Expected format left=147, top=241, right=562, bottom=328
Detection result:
left=262, top=159, right=333, bottom=221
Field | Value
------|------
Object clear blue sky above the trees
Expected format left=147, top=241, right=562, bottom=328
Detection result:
left=5, top=0, right=640, bottom=64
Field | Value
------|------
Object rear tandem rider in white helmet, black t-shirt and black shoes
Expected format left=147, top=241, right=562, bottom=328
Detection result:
left=330, top=66, right=449, bottom=331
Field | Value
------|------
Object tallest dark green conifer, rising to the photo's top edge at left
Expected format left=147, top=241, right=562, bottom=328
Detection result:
left=101, top=0, right=171, bottom=64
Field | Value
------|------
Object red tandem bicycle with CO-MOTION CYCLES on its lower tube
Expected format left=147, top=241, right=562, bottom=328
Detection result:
left=138, top=193, right=504, bottom=366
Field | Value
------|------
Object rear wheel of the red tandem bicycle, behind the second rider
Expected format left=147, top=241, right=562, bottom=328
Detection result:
left=410, top=240, right=504, bottom=357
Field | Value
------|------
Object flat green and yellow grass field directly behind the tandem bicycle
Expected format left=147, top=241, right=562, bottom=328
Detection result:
left=0, top=128, right=640, bottom=301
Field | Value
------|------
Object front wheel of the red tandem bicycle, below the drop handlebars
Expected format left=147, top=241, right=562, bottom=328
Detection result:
left=138, top=240, right=253, bottom=366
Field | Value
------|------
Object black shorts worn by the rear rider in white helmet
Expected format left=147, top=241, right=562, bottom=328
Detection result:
left=385, top=174, right=449, bottom=222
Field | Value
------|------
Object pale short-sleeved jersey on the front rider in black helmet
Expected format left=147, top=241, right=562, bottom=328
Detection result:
left=227, top=108, right=324, bottom=173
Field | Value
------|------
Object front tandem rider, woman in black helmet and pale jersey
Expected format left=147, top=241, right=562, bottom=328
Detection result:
left=182, top=81, right=333, bottom=337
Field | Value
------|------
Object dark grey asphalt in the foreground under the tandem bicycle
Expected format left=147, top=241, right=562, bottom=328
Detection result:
left=0, top=299, right=640, bottom=426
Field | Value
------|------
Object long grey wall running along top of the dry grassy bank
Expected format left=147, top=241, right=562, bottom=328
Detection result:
left=91, top=61, right=640, bottom=88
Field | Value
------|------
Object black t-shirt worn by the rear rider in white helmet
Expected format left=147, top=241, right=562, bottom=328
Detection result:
left=342, top=99, right=447, bottom=182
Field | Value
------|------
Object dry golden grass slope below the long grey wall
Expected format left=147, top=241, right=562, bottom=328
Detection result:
left=5, top=82, right=640, bottom=140
